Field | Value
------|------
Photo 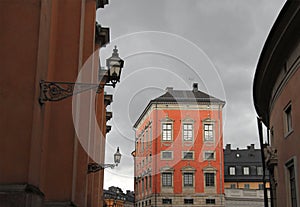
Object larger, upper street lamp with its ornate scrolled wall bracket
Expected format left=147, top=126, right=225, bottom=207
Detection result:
left=39, top=46, right=124, bottom=104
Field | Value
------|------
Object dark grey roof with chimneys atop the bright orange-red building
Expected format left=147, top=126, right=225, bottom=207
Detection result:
left=134, top=83, right=225, bottom=128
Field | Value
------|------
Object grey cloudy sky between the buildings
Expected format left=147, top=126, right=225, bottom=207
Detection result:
left=97, top=0, right=285, bottom=190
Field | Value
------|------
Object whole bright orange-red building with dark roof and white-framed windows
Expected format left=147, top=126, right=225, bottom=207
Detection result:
left=134, top=84, right=225, bottom=207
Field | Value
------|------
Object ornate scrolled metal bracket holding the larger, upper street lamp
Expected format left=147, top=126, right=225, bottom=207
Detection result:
left=39, top=80, right=103, bottom=104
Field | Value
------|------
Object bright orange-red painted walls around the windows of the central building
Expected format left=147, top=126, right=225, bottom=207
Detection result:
left=135, top=102, right=224, bottom=205
